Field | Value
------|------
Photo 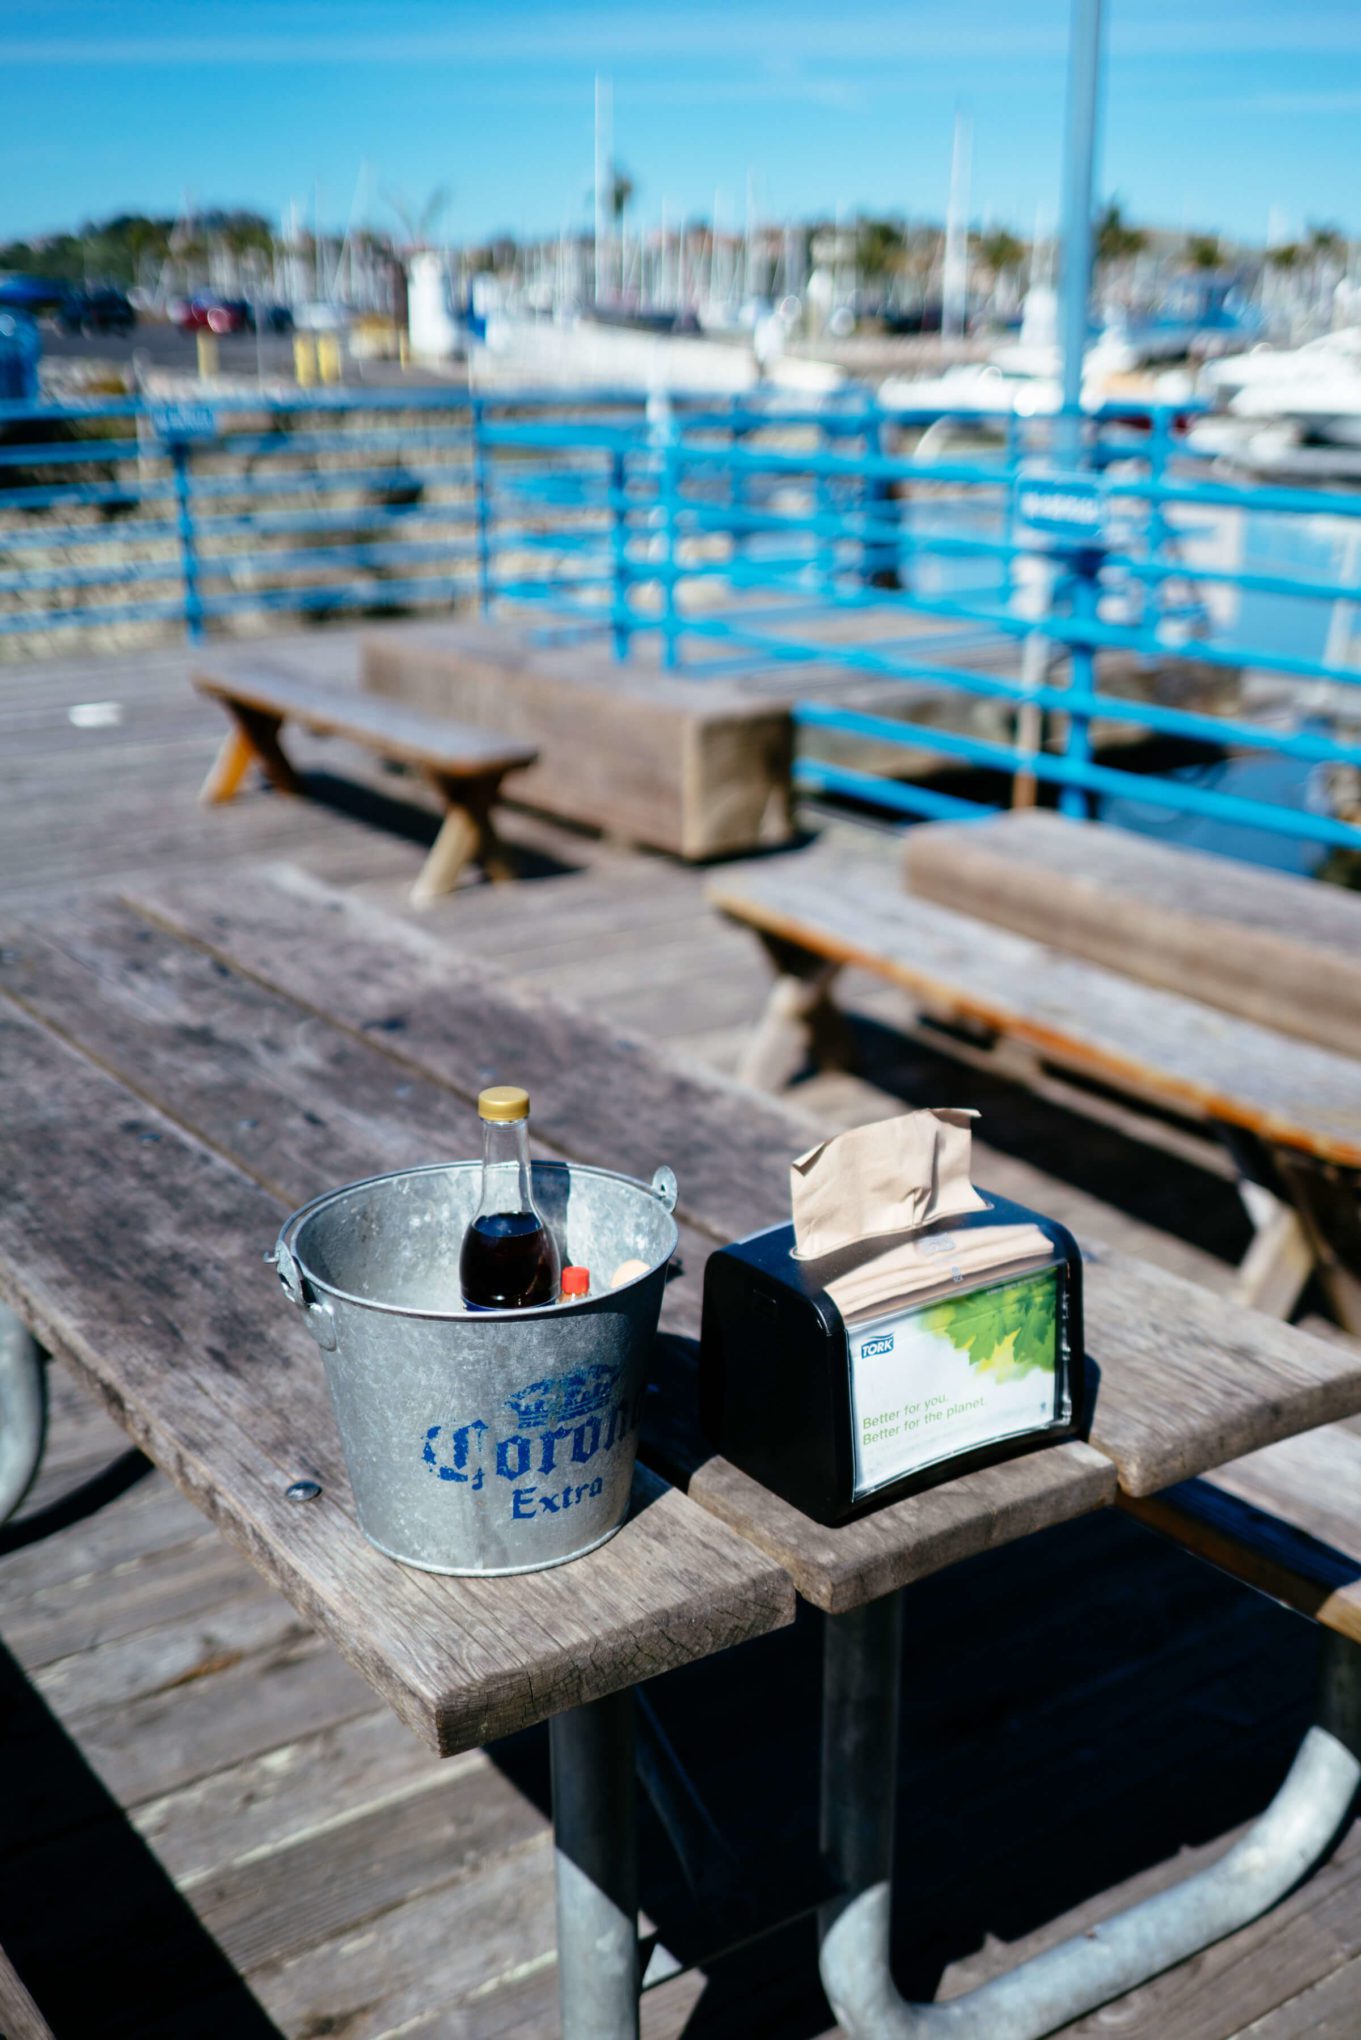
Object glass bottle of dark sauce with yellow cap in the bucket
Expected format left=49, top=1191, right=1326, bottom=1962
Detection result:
left=459, top=1083, right=559, bottom=1310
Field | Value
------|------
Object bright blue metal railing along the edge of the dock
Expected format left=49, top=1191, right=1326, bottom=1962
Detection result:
left=0, top=388, right=1361, bottom=851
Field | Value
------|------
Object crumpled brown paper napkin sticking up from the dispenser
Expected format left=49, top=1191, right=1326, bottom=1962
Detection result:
left=790, top=1106, right=988, bottom=1261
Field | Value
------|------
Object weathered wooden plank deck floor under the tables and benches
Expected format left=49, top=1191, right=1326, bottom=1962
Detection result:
left=0, top=632, right=1361, bottom=2040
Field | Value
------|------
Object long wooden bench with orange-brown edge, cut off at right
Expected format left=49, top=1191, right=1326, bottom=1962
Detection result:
left=708, top=851, right=1361, bottom=1330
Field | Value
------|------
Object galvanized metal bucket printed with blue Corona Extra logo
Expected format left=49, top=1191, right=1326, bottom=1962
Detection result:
left=271, top=1161, right=677, bottom=1573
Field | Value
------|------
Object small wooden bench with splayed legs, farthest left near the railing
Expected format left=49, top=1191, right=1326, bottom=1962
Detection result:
left=194, top=661, right=537, bottom=904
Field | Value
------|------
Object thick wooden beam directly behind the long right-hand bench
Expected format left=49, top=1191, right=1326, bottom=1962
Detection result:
left=904, top=810, right=1361, bottom=1055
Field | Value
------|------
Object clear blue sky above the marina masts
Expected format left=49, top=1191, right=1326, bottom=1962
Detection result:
left=0, top=0, right=1361, bottom=239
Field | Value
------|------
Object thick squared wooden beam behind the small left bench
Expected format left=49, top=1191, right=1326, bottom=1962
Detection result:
left=361, top=622, right=794, bottom=859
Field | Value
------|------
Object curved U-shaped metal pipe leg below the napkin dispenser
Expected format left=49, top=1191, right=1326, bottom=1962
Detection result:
left=820, top=1595, right=1361, bottom=2040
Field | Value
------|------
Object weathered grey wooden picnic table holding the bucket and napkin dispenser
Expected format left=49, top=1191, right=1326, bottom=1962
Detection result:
left=0, top=869, right=1361, bottom=2034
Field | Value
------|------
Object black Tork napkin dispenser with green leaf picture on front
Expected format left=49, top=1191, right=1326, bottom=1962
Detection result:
left=700, top=1193, right=1083, bottom=1524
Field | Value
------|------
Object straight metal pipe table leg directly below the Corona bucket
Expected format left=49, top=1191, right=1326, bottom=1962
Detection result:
left=549, top=1691, right=641, bottom=2040
